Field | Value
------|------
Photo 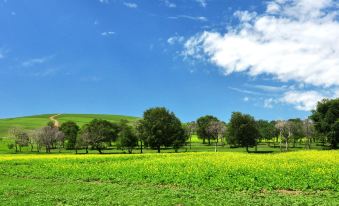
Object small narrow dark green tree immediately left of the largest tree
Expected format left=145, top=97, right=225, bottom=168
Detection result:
left=118, top=124, right=138, bottom=154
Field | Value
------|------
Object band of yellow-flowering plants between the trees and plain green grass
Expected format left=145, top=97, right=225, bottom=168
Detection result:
left=0, top=151, right=339, bottom=204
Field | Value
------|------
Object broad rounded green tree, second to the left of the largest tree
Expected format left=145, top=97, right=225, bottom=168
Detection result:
left=82, top=119, right=119, bottom=154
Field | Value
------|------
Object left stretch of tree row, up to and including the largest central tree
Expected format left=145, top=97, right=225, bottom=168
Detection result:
left=9, top=107, right=188, bottom=153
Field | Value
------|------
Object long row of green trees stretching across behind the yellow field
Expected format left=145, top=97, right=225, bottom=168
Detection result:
left=8, top=99, right=339, bottom=153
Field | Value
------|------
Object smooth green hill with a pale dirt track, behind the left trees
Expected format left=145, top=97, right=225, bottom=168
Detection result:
left=0, top=114, right=139, bottom=137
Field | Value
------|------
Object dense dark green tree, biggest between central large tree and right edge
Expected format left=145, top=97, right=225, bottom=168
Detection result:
left=228, top=112, right=260, bottom=152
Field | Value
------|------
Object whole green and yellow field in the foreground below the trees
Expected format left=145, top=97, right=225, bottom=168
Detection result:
left=0, top=151, right=339, bottom=205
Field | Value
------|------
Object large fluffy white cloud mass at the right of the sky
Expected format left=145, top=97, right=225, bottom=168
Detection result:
left=184, top=0, right=339, bottom=110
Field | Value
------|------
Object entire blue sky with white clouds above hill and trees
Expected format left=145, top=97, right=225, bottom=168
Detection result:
left=0, top=0, right=339, bottom=121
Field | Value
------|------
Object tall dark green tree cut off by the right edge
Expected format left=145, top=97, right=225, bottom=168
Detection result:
left=310, top=99, right=339, bottom=149
